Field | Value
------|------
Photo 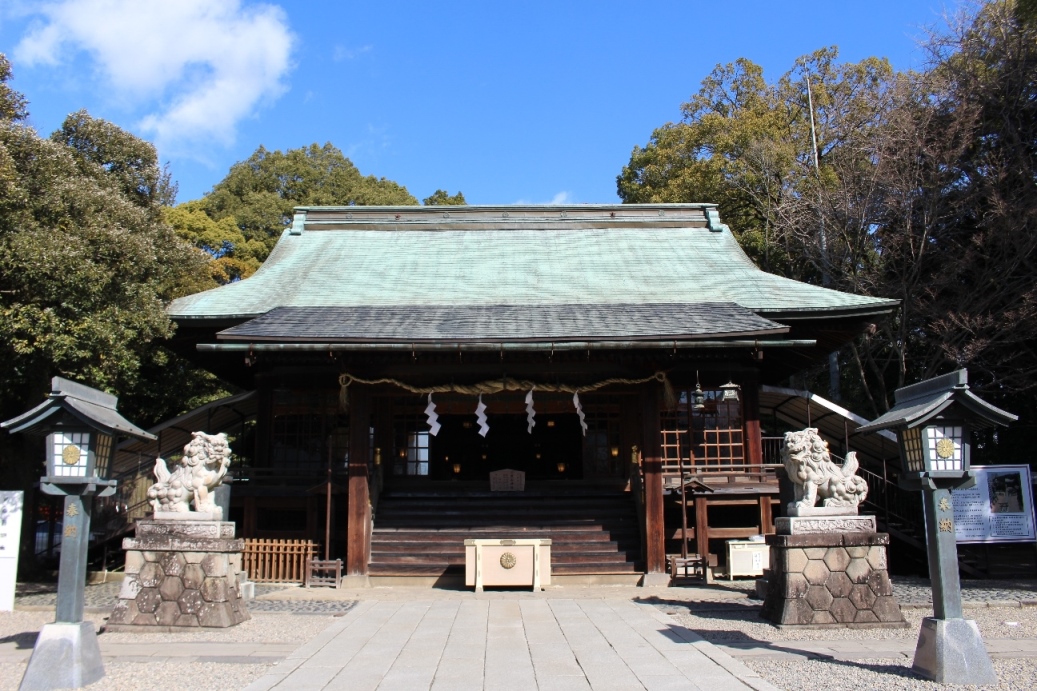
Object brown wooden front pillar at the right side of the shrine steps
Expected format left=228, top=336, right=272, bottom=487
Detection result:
left=641, top=384, right=666, bottom=574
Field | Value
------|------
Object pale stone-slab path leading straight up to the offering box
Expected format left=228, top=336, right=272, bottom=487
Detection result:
left=247, top=599, right=775, bottom=691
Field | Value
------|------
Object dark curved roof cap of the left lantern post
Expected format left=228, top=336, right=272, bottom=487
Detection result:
left=0, top=377, right=156, bottom=440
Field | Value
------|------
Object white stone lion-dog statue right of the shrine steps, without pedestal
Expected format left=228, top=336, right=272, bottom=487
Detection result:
left=781, top=427, right=868, bottom=514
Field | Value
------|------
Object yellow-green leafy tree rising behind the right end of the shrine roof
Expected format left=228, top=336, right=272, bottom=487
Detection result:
left=617, top=48, right=893, bottom=283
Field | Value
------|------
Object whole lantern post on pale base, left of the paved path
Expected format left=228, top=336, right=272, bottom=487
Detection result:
left=0, top=377, right=156, bottom=689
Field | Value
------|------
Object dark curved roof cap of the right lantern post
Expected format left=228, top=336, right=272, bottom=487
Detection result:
left=858, top=369, right=1019, bottom=433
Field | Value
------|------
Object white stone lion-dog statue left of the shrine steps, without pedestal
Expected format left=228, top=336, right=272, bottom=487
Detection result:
left=147, top=432, right=230, bottom=521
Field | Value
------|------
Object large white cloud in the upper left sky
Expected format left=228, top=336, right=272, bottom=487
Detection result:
left=13, top=0, right=295, bottom=150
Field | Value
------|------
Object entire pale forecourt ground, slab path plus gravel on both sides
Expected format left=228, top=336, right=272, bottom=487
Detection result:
left=6, top=579, right=1037, bottom=691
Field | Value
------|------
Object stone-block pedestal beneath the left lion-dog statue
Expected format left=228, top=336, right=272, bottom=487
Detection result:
left=106, top=520, right=250, bottom=633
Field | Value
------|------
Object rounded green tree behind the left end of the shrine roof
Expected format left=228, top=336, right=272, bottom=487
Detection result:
left=199, top=143, right=418, bottom=260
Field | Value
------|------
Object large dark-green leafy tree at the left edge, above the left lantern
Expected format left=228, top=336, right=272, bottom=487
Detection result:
left=0, top=56, right=231, bottom=569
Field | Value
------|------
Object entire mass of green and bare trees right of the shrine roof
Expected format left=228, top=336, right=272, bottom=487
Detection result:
left=617, top=0, right=1037, bottom=435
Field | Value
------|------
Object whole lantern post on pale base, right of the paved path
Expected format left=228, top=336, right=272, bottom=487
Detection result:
left=858, top=369, right=1017, bottom=685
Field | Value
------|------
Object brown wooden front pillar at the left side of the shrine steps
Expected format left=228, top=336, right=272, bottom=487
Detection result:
left=345, top=384, right=371, bottom=576
